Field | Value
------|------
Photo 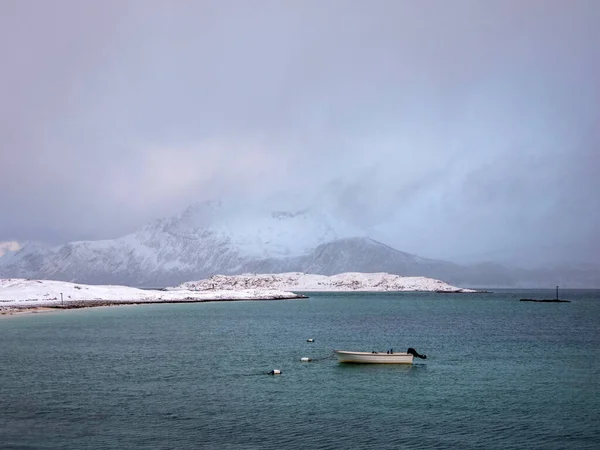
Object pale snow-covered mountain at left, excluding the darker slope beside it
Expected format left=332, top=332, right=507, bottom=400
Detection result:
left=0, top=202, right=360, bottom=286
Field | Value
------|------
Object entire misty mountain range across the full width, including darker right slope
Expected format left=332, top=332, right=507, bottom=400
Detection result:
left=0, top=202, right=600, bottom=287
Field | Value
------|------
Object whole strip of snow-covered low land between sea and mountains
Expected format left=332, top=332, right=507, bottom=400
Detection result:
left=0, top=272, right=478, bottom=310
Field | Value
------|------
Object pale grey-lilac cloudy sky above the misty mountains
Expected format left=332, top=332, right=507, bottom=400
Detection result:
left=0, top=0, right=600, bottom=264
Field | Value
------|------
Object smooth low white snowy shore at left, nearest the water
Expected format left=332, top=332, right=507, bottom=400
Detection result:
left=0, top=278, right=301, bottom=309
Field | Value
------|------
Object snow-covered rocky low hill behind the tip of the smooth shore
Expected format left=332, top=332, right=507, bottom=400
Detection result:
left=170, top=272, right=477, bottom=292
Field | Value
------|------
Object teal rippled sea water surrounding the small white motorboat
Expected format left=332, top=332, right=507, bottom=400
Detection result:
left=0, top=291, right=600, bottom=449
